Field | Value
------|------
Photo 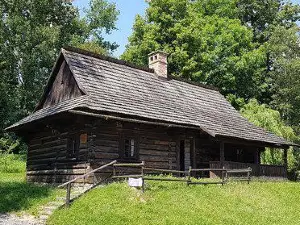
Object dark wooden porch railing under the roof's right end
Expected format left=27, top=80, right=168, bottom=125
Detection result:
left=209, top=161, right=287, bottom=178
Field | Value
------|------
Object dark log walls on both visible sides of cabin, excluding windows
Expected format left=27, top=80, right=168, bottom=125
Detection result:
left=27, top=116, right=211, bottom=183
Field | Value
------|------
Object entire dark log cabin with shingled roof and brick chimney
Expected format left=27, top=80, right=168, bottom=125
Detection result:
left=7, top=47, right=293, bottom=183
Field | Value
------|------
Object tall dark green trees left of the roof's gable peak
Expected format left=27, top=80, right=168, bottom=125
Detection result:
left=0, top=0, right=118, bottom=132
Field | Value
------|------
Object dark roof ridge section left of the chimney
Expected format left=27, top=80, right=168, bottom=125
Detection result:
left=63, top=46, right=154, bottom=73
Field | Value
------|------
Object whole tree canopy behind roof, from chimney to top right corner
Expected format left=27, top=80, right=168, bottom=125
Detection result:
left=122, top=0, right=300, bottom=106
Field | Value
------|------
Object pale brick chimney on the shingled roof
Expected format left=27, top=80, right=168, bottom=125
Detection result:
left=148, top=51, right=168, bottom=78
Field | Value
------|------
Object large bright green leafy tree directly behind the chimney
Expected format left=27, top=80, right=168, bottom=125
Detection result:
left=122, top=0, right=265, bottom=102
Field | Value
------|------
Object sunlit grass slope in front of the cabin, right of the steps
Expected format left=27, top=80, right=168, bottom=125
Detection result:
left=48, top=178, right=300, bottom=225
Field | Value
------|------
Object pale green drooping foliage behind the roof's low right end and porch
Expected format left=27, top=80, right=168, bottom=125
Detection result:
left=241, top=99, right=300, bottom=170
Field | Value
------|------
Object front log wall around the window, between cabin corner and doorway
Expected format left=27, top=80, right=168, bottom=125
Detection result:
left=91, top=120, right=177, bottom=172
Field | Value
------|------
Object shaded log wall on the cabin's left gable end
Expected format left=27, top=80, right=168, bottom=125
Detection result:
left=26, top=125, right=89, bottom=183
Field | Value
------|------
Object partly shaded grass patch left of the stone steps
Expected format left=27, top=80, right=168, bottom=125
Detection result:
left=0, top=156, right=63, bottom=215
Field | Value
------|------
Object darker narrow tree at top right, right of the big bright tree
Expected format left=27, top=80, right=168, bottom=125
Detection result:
left=237, top=0, right=300, bottom=104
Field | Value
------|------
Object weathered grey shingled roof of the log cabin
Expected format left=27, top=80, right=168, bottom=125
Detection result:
left=8, top=48, right=290, bottom=145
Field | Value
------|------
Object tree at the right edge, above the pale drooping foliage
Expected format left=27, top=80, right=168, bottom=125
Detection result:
left=268, top=26, right=300, bottom=128
